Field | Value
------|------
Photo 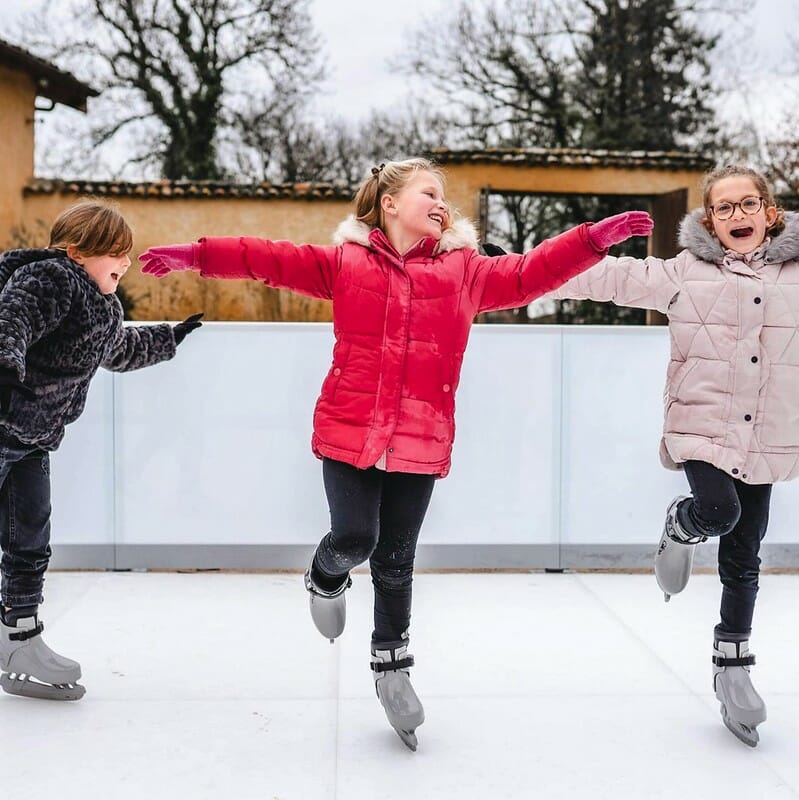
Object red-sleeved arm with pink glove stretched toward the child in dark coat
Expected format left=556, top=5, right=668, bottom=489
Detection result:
left=139, top=236, right=340, bottom=299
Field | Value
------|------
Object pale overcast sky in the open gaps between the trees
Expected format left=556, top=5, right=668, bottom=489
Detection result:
left=0, top=0, right=799, bottom=175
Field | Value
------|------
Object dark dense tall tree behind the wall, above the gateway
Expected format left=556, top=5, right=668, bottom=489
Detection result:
left=564, top=0, right=718, bottom=150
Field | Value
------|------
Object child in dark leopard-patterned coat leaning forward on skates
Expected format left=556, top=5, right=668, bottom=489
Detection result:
left=0, top=202, right=201, bottom=700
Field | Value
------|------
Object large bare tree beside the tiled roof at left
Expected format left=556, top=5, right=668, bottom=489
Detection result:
left=17, top=0, right=322, bottom=179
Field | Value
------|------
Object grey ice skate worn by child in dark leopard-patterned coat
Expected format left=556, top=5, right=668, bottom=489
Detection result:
left=0, top=615, right=86, bottom=700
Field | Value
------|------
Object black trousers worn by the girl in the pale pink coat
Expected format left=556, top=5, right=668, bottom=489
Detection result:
left=677, top=461, right=771, bottom=642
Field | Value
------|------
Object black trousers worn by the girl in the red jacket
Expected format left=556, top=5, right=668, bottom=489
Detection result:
left=312, top=458, right=436, bottom=644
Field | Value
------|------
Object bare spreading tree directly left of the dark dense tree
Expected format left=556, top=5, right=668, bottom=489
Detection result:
left=398, top=0, right=578, bottom=147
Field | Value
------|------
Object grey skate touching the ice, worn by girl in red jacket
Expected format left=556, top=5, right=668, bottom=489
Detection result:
left=371, top=644, right=424, bottom=751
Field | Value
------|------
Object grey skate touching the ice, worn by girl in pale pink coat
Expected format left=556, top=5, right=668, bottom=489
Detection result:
left=713, top=641, right=766, bottom=747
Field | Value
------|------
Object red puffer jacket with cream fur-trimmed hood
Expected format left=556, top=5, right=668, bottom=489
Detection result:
left=199, top=217, right=604, bottom=477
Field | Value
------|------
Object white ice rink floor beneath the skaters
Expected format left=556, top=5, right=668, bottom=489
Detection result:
left=0, top=572, right=799, bottom=800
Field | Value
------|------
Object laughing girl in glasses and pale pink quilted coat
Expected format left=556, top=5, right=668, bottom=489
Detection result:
left=550, top=166, right=799, bottom=747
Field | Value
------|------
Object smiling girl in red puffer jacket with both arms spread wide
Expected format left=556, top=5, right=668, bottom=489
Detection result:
left=141, top=158, right=652, bottom=750
